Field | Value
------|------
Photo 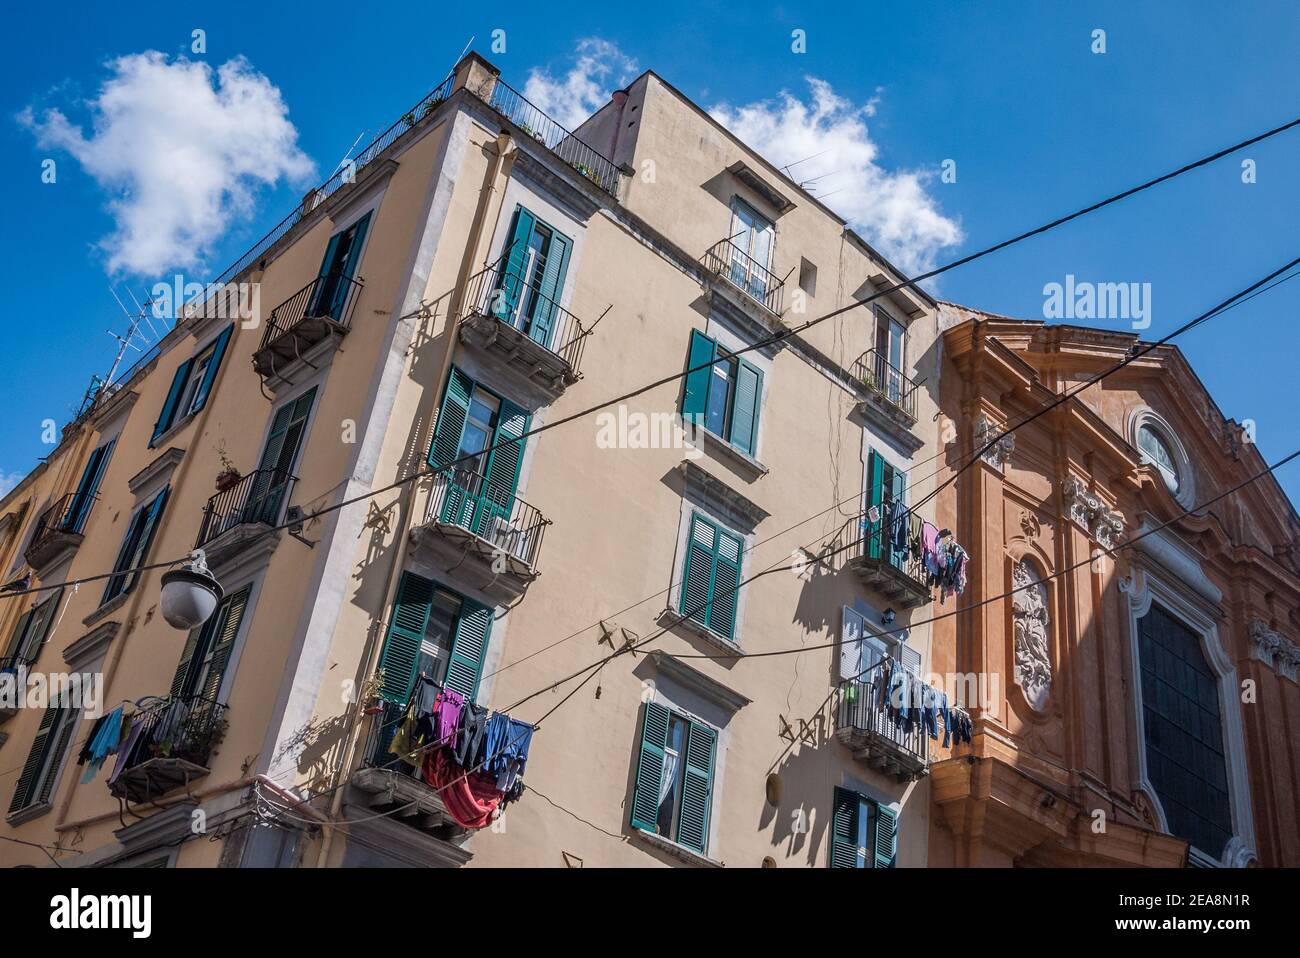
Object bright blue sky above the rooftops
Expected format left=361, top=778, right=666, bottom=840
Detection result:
left=0, top=0, right=1300, bottom=509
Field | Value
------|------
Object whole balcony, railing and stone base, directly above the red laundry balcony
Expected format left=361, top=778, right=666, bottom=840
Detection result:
left=411, top=468, right=550, bottom=603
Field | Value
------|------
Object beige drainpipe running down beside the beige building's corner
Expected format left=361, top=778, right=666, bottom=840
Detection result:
left=315, top=133, right=515, bottom=868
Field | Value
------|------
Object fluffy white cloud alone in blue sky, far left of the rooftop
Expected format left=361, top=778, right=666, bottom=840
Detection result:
left=18, top=51, right=315, bottom=276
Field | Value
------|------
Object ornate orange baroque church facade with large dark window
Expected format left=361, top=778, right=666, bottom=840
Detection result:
left=930, top=305, right=1300, bottom=866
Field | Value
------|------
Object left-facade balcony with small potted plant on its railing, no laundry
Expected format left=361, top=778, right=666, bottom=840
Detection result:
left=194, top=469, right=298, bottom=569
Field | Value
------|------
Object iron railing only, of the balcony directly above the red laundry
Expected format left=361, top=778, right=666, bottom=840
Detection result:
left=425, top=467, right=551, bottom=569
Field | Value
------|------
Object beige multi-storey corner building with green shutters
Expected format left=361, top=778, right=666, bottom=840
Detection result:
left=0, top=55, right=956, bottom=867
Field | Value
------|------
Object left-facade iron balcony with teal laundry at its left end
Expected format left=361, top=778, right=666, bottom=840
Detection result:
left=108, top=695, right=229, bottom=802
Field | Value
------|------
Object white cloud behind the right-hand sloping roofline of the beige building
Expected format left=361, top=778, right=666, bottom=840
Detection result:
left=710, top=77, right=962, bottom=276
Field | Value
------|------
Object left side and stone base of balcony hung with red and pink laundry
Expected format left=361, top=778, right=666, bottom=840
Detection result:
left=351, top=702, right=465, bottom=841
